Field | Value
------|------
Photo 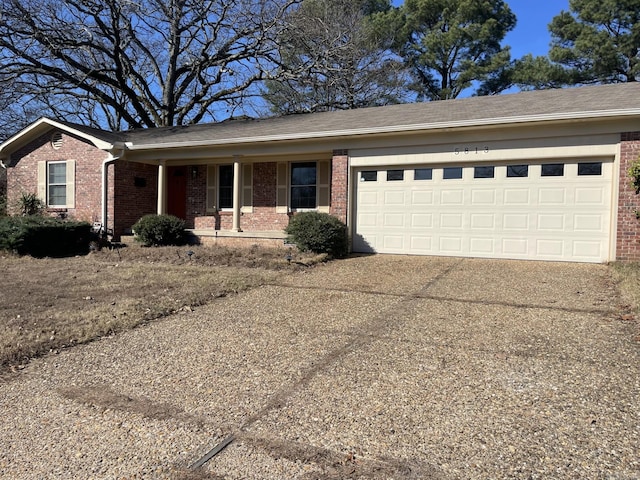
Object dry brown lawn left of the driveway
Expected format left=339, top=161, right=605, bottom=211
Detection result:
left=0, top=246, right=321, bottom=372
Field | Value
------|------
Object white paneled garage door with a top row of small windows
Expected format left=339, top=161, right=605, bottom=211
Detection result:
left=353, top=161, right=613, bottom=262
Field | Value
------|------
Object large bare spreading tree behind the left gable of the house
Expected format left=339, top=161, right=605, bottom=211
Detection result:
left=0, top=0, right=299, bottom=129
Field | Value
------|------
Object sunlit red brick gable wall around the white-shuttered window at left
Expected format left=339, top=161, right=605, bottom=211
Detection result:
left=7, top=131, right=108, bottom=222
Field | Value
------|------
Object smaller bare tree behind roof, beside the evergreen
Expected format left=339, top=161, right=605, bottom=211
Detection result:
left=264, top=0, right=407, bottom=114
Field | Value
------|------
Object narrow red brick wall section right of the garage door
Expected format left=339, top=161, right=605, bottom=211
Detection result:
left=616, top=132, right=640, bottom=261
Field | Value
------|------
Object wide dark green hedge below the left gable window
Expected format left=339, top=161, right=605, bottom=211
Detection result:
left=0, top=215, right=91, bottom=258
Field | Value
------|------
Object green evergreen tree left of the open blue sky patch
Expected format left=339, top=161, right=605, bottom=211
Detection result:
left=376, top=0, right=516, bottom=100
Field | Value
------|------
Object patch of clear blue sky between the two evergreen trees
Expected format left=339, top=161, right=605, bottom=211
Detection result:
left=392, top=0, right=569, bottom=59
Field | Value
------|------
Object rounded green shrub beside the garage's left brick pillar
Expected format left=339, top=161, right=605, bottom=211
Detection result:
left=285, top=212, right=347, bottom=258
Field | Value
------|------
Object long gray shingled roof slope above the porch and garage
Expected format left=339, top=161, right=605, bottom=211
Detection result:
left=121, top=83, right=640, bottom=149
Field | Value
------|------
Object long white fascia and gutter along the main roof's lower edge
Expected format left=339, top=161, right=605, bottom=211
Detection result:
left=127, top=109, right=640, bottom=150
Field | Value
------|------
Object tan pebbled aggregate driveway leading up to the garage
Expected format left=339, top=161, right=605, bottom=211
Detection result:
left=0, top=256, right=640, bottom=479
